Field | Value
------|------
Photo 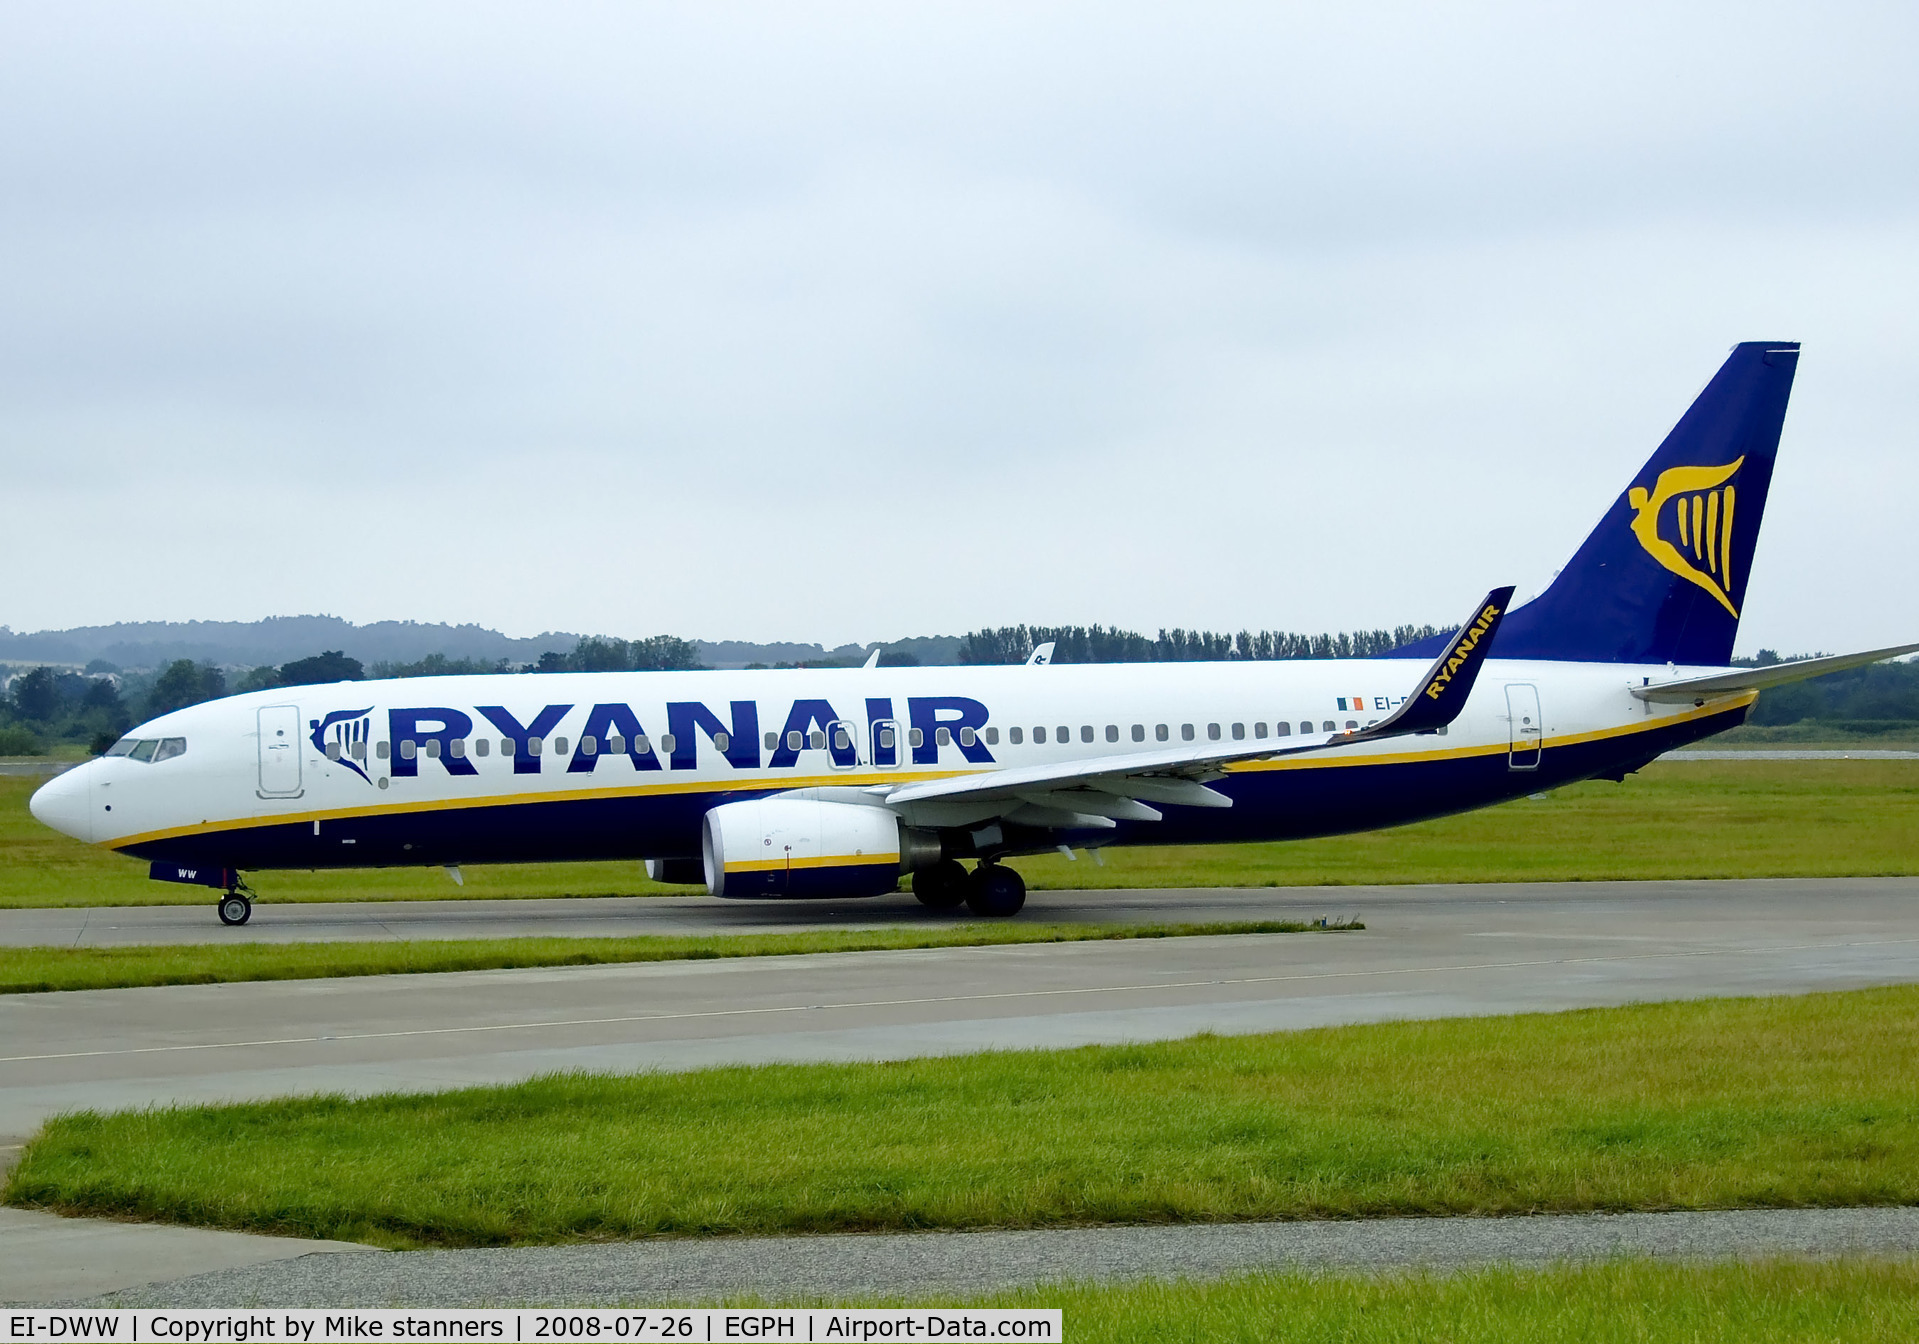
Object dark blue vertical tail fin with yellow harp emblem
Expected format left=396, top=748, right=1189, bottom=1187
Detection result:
left=1395, top=342, right=1798, bottom=666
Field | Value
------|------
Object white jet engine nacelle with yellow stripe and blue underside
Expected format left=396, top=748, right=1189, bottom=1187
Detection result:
left=700, top=799, right=900, bottom=900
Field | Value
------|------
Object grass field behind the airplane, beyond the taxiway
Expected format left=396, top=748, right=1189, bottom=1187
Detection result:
left=0, top=760, right=1919, bottom=908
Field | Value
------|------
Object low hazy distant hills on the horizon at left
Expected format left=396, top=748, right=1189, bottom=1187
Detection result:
left=0, top=616, right=960, bottom=672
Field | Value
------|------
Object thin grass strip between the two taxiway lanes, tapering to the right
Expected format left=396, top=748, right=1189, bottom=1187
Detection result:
left=0, top=920, right=1335, bottom=995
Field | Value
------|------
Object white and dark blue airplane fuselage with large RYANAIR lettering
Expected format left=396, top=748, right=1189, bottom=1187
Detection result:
left=36, top=659, right=1754, bottom=870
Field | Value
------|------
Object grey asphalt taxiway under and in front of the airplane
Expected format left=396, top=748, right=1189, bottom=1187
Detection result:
left=0, top=877, right=1919, bottom=1137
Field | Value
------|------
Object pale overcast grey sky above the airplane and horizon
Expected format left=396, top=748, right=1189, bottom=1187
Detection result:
left=0, top=0, right=1919, bottom=651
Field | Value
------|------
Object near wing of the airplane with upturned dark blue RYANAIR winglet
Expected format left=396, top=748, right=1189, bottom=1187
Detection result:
left=875, top=588, right=1512, bottom=828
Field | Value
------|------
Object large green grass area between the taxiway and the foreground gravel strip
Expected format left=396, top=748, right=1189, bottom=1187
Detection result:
left=6, top=987, right=1919, bottom=1246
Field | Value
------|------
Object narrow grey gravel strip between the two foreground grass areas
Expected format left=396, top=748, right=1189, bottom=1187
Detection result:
left=78, top=1208, right=1919, bottom=1308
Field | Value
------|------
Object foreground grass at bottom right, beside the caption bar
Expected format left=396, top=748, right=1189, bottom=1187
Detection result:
left=977, top=1260, right=1919, bottom=1344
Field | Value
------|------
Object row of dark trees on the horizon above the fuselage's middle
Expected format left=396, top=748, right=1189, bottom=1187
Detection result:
left=960, top=626, right=1441, bottom=666
